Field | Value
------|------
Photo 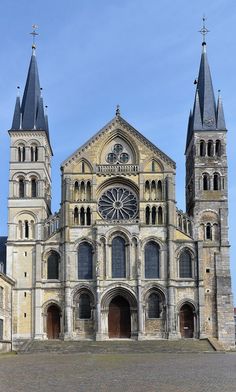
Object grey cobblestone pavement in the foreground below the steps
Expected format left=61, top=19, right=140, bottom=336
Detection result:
left=0, top=352, right=236, bottom=392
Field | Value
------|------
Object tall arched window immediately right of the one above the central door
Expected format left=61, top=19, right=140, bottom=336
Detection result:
left=145, top=241, right=160, bottom=279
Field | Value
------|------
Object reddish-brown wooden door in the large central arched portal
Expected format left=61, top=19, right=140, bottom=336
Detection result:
left=108, top=296, right=131, bottom=338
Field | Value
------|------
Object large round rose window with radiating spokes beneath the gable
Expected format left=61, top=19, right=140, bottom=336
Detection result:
left=98, top=187, right=138, bottom=220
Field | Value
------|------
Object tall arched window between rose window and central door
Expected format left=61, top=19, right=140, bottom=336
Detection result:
left=112, top=236, right=126, bottom=278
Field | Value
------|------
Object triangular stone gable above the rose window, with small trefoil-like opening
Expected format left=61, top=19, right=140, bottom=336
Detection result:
left=62, top=116, right=175, bottom=172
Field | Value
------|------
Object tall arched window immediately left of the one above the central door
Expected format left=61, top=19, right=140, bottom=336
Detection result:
left=78, top=242, right=93, bottom=279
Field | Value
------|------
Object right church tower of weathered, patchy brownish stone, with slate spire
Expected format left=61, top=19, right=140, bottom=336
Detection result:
left=186, top=21, right=234, bottom=344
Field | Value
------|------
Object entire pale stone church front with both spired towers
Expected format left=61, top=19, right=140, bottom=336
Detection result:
left=4, top=37, right=234, bottom=347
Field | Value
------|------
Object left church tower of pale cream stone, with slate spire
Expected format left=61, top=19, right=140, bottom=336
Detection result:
left=7, top=39, right=52, bottom=339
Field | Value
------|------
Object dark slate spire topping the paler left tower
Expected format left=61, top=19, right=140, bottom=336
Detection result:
left=12, top=45, right=47, bottom=131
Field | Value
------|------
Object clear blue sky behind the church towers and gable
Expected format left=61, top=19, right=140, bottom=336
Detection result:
left=0, top=0, right=236, bottom=302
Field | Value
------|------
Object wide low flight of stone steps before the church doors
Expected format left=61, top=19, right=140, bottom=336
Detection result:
left=18, top=339, right=215, bottom=354
